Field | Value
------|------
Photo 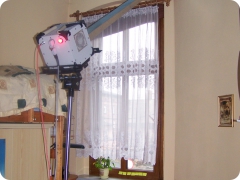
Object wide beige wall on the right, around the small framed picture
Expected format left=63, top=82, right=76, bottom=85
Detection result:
left=174, top=0, right=240, bottom=180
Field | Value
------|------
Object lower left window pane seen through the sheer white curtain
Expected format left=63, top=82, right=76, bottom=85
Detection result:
left=99, top=77, right=122, bottom=156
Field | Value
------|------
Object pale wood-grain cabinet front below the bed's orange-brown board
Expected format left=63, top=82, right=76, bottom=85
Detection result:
left=0, top=124, right=53, bottom=180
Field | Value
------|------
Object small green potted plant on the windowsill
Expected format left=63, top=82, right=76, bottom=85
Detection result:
left=93, top=157, right=115, bottom=179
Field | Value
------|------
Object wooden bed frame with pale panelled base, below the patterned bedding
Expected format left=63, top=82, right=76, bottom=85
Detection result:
left=0, top=109, right=64, bottom=180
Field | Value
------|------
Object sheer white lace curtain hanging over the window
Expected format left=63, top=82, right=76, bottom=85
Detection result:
left=76, top=6, right=159, bottom=165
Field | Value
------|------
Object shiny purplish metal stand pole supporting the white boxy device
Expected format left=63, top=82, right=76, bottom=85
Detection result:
left=64, top=88, right=74, bottom=180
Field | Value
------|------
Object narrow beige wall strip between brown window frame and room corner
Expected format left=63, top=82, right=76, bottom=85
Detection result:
left=163, top=1, right=176, bottom=180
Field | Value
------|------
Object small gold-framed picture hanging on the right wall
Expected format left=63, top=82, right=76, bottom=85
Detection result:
left=218, top=94, right=234, bottom=127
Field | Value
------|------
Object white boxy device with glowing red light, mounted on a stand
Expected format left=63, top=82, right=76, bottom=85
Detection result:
left=36, top=21, right=93, bottom=66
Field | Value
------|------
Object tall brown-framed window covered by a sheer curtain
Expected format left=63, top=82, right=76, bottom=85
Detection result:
left=76, top=5, right=164, bottom=179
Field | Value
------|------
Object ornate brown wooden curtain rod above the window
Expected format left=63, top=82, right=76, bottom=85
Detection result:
left=69, top=0, right=171, bottom=21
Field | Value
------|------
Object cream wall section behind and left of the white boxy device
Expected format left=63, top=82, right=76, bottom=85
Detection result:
left=0, top=0, right=68, bottom=68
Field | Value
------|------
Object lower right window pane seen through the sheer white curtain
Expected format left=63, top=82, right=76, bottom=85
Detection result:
left=128, top=75, right=158, bottom=163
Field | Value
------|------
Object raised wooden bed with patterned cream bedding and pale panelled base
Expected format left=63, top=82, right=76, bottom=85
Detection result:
left=0, top=65, right=67, bottom=180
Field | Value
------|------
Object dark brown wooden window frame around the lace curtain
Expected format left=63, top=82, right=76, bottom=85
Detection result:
left=89, top=4, right=164, bottom=180
